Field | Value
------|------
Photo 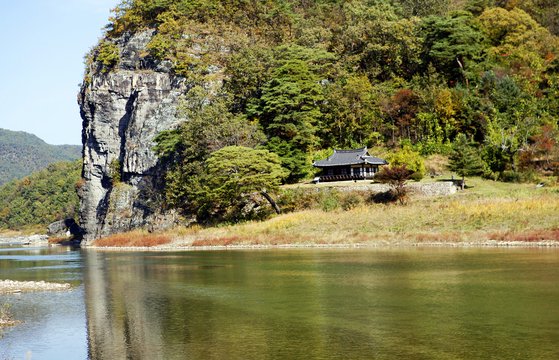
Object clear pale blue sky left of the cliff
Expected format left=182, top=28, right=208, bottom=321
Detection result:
left=0, top=0, right=120, bottom=145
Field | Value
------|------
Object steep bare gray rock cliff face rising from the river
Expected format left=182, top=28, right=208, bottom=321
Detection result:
left=78, top=31, right=189, bottom=245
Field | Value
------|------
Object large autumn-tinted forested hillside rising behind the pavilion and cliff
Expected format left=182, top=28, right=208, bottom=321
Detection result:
left=85, top=0, right=559, bottom=221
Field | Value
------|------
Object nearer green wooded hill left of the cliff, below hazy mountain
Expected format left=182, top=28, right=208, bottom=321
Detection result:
left=0, top=160, right=81, bottom=230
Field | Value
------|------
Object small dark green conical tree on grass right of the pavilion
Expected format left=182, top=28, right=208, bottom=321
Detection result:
left=449, top=134, right=486, bottom=190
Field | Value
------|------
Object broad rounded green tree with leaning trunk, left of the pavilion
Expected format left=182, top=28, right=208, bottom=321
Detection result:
left=197, top=146, right=287, bottom=221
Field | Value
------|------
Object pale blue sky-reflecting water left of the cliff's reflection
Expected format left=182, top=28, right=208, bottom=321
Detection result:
left=0, top=246, right=87, bottom=360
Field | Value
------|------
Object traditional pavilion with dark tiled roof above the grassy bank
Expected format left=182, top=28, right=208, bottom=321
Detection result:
left=313, top=147, right=388, bottom=182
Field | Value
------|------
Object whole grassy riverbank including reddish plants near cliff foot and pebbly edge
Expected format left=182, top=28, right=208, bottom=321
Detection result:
left=86, top=179, right=559, bottom=250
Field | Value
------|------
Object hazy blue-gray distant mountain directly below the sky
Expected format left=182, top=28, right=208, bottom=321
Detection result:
left=0, top=129, right=81, bottom=185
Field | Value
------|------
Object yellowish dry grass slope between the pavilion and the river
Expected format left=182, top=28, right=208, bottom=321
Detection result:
left=180, top=188, right=559, bottom=246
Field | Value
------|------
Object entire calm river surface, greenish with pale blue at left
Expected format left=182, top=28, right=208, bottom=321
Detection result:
left=0, top=247, right=559, bottom=360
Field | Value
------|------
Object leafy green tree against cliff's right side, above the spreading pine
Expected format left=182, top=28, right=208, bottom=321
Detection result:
left=154, top=87, right=264, bottom=212
